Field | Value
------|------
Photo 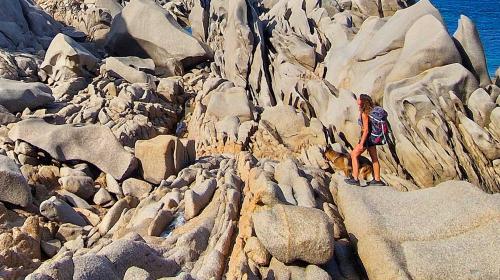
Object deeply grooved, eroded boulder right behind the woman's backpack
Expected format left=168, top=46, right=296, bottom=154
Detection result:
left=381, top=63, right=498, bottom=192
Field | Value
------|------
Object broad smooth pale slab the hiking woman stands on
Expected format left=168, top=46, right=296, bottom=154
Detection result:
left=337, top=181, right=500, bottom=280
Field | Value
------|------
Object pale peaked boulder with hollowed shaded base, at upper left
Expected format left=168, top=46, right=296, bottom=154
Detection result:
left=40, top=33, right=99, bottom=81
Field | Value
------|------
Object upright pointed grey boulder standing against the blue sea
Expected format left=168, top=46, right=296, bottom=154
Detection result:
left=453, top=15, right=491, bottom=87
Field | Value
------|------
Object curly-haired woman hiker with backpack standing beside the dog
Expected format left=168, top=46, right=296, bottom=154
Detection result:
left=345, top=94, right=388, bottom=186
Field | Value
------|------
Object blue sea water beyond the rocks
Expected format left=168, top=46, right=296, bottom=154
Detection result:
left=431, top=0, right=500, bottom=76
